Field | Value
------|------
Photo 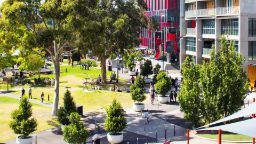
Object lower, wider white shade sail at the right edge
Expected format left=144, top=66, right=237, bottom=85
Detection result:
left=202, top=118, right=256, bottom=138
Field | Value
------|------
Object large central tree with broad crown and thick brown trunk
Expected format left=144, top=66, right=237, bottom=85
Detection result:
left=78, top=0, right=146, bottom=82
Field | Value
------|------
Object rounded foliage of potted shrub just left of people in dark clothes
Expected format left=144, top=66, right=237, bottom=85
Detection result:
left=155, top=72, right=171, bottom=96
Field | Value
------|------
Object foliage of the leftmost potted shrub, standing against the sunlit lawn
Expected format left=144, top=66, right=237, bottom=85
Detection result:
left=10, top=98, right=37, bottom=139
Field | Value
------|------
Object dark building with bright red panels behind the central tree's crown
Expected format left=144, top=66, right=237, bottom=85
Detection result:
left=140, top=0, right=180, bottom=63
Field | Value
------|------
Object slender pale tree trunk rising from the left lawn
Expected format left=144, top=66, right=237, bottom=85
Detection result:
left=52, top=41, right=60, bottom=116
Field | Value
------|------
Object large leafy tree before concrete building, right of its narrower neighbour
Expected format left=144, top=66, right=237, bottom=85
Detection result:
left=201, top=38, right=248, bottom=123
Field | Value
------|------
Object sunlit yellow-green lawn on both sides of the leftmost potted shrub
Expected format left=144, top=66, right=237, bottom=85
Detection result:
left=0, top=96, right=56, bottom=143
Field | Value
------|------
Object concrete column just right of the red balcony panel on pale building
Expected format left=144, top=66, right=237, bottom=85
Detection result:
left=196, top=19, right=204, bottom=64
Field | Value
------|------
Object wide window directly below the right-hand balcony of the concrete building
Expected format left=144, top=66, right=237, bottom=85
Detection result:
left=221, top=19, right=238, bottom=35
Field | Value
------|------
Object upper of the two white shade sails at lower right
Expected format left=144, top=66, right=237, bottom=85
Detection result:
left=198, top=104, right=256, bottom=129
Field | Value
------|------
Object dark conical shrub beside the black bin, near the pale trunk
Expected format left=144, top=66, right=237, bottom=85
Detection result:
left=57, top=90, right=76, bottom=125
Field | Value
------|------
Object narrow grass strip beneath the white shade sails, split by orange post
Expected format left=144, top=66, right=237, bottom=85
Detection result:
left=198, top=134, right=252, bottom=141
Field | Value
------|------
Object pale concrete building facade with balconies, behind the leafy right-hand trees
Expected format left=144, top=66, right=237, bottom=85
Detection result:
left=180, top=0, right=256, bottom=75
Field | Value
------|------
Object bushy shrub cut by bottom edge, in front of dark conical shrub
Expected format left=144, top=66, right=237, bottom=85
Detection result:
left=63, top=112, right=89, bottom=144
